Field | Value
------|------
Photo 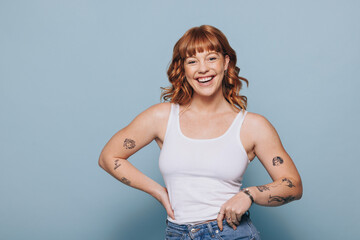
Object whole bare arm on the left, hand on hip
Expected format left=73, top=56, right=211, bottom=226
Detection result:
left=99, top=103, right=174, bottom=219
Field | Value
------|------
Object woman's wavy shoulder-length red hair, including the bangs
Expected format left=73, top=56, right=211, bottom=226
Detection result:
left=161, top=25, right=249, bottom=110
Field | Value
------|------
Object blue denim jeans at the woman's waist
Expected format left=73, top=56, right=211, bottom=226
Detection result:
left=165, top=214, right=260, bottom=240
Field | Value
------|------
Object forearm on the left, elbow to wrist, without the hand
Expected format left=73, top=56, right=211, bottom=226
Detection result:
left=99, top=157, right=164, bottom=200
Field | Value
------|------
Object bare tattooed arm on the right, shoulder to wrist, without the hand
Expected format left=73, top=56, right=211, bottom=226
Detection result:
left=248, top=114, right=303, bottom=206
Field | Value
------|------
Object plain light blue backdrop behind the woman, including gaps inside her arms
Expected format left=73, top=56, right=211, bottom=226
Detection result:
left=0, top=0, right=360, bottom=240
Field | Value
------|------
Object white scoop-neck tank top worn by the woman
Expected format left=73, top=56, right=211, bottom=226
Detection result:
left=159, top=103, right=250, bottom=224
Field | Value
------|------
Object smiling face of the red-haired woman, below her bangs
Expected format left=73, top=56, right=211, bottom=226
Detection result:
left=184, top=51, right=230, bottom=97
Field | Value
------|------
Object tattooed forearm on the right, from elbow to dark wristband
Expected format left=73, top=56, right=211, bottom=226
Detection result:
left=249, top=177, right=302, bottom=206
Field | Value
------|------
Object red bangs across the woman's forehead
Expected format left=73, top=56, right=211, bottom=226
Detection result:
left=179, top=28, right=223, bottom=59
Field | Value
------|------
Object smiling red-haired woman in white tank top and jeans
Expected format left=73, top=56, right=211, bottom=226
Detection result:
left=99, top=25, right=302, bottom=240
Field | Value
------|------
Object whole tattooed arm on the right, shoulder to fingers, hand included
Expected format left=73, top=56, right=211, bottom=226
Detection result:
left=217, top=113, right=303, bottom=230
